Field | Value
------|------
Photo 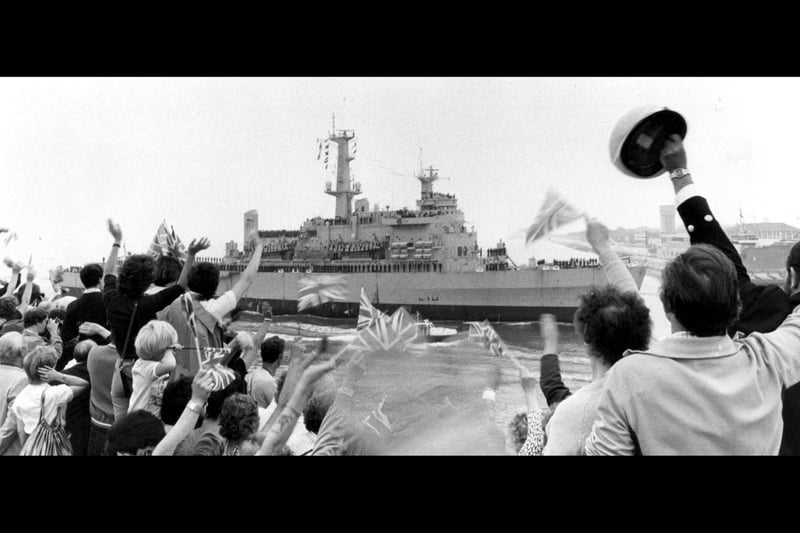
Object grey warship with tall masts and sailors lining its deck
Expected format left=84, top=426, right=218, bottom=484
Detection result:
left=61, top=126, right=646, bottom=322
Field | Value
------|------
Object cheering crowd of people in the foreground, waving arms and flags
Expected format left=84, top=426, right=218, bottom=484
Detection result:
left=0, top=136, right=800, bottom=456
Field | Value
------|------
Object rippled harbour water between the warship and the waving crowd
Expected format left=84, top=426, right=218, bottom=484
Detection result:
left=236, top=271, right=669, bottom=453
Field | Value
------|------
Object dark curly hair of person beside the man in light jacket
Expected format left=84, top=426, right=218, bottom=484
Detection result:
left=575, top=285, right=653, bottom=366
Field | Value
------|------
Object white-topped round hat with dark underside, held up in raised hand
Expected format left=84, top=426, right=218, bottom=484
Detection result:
left=609, top=106, right=687, bottom=178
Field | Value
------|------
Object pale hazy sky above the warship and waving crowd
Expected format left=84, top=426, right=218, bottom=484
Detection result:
left=0, top=77, right=800, bottom=278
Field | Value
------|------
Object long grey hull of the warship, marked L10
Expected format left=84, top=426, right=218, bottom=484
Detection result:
left=62, top=266, right=646, bottom=322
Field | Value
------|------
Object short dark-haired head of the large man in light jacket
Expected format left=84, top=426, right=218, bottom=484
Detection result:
left=661, top=244, right=740, bottom=337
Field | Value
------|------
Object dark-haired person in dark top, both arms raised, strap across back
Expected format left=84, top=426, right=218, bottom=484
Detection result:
left=103, top=220, right=210, bottom=418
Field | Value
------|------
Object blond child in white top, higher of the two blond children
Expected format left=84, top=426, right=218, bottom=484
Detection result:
left=128, top=320, right=179, bottom=416
